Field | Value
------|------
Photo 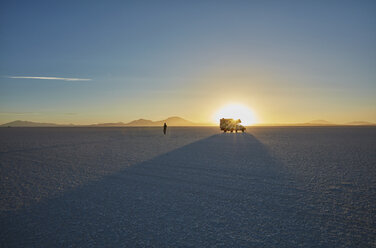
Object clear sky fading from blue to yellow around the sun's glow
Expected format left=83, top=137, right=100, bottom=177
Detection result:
left=0, top=0, right=376, bottom=124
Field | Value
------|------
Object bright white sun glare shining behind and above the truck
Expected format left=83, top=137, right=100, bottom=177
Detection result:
left=214, top=104, right=256, bottom=126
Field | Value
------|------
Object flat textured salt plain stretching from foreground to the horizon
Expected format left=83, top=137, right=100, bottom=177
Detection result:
left=0, top=127, right=376, bottom=247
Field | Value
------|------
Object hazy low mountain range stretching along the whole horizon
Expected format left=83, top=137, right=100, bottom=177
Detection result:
left=0, top=116, right=376, bottom=127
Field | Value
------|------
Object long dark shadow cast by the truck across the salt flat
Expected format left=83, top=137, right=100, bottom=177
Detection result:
left=0, top=133, right=319, bottom=247
